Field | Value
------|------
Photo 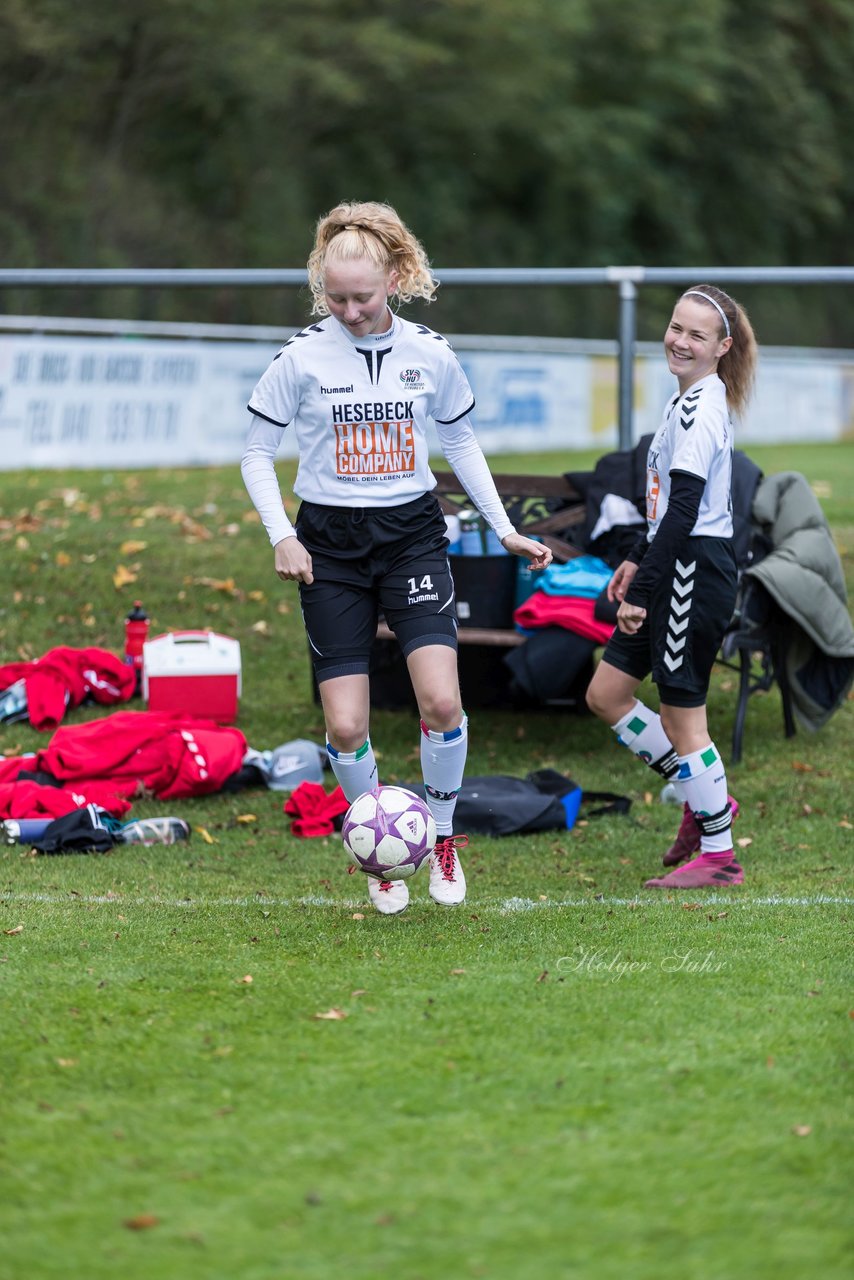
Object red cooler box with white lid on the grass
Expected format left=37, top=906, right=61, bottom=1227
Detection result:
left=142, top=631, right=241, bottom=724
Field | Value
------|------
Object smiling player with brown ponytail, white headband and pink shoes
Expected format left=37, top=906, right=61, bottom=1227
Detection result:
left=588, top=284, right=757, bottom=888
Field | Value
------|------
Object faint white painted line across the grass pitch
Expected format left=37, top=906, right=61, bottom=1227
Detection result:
left=0, top=890, right=854, bottom=915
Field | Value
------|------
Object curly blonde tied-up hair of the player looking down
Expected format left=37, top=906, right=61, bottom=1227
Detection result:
left=307, top=201, right=439, bottom=316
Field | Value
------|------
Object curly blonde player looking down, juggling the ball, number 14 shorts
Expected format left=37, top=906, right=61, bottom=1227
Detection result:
left=242, top=202, right=552, bottom=915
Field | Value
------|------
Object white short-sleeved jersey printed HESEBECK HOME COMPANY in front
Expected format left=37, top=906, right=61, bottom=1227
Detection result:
left=248, top=316, right=474, bottom=507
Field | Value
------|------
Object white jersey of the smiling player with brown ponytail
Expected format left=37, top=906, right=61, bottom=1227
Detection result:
left=647, top=374, right=732, bottom=541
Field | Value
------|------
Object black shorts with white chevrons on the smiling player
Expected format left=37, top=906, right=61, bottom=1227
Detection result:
left=603, top=538, right=737, bottom=707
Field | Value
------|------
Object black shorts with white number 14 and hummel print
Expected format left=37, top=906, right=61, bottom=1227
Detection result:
left=296, top=493, right=457, bottom=682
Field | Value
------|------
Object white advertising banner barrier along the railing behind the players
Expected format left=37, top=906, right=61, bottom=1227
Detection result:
left=0, top=326, right=854, bottom=470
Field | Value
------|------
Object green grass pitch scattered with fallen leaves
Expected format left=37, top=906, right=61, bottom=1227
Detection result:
left=0, top=445, right=854, bottom=1280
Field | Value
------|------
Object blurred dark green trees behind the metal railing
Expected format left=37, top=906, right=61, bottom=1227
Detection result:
left=0, top=0, right=854, bottom=346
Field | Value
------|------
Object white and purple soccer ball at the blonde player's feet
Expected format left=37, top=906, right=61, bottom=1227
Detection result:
left=341, top=786, right=435, bottom=879
